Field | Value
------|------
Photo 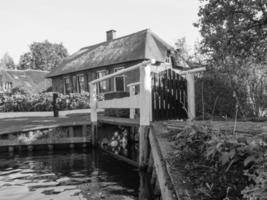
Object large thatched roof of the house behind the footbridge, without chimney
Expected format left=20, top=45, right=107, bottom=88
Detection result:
left=47, top=29, right=173, bottom=78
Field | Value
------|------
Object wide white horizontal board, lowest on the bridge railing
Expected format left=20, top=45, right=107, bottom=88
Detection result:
left=97, top=94, right=141, bottom=109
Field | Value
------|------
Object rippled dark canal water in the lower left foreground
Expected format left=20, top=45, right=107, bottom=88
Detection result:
left=0, top=150, right=144, bottom=200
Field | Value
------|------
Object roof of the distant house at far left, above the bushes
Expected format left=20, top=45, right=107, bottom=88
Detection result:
left=0, top=70, right=52, bottom=94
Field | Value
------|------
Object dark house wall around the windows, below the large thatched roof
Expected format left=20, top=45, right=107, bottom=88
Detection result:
left=52, top=60, right=143, bottom=93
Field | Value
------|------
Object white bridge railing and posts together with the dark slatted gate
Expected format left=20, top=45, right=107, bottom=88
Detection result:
left=89, top=60, right=205, bottom=126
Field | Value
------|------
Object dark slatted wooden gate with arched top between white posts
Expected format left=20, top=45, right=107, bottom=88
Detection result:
left=152, top=69, right=188, bottom=121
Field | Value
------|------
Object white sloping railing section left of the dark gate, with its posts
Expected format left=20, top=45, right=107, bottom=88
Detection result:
left=89, top=61, right=152, bottom=125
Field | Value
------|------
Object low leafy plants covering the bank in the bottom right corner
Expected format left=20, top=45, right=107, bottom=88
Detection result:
left=174, top=126, right=267, bottom=200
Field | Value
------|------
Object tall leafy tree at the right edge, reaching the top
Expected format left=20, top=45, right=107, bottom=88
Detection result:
left=195, top=0, right=267, bottom=115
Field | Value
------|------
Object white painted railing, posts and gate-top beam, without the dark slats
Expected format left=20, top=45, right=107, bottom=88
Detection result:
left=89, top=61, right=205, bottom=126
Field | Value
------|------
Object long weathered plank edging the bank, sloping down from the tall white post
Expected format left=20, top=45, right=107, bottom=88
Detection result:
left=149, top=129, right=177, bottom=200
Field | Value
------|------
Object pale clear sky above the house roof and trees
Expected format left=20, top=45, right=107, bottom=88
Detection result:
left=0, top=0, right=200, bottom=63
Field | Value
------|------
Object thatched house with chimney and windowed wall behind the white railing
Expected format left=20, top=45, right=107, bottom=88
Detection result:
left=47, top=29, right=178, bottom=93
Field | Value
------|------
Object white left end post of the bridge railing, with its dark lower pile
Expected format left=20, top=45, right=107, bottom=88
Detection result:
left=90, top=83, right=97, bottom=146
